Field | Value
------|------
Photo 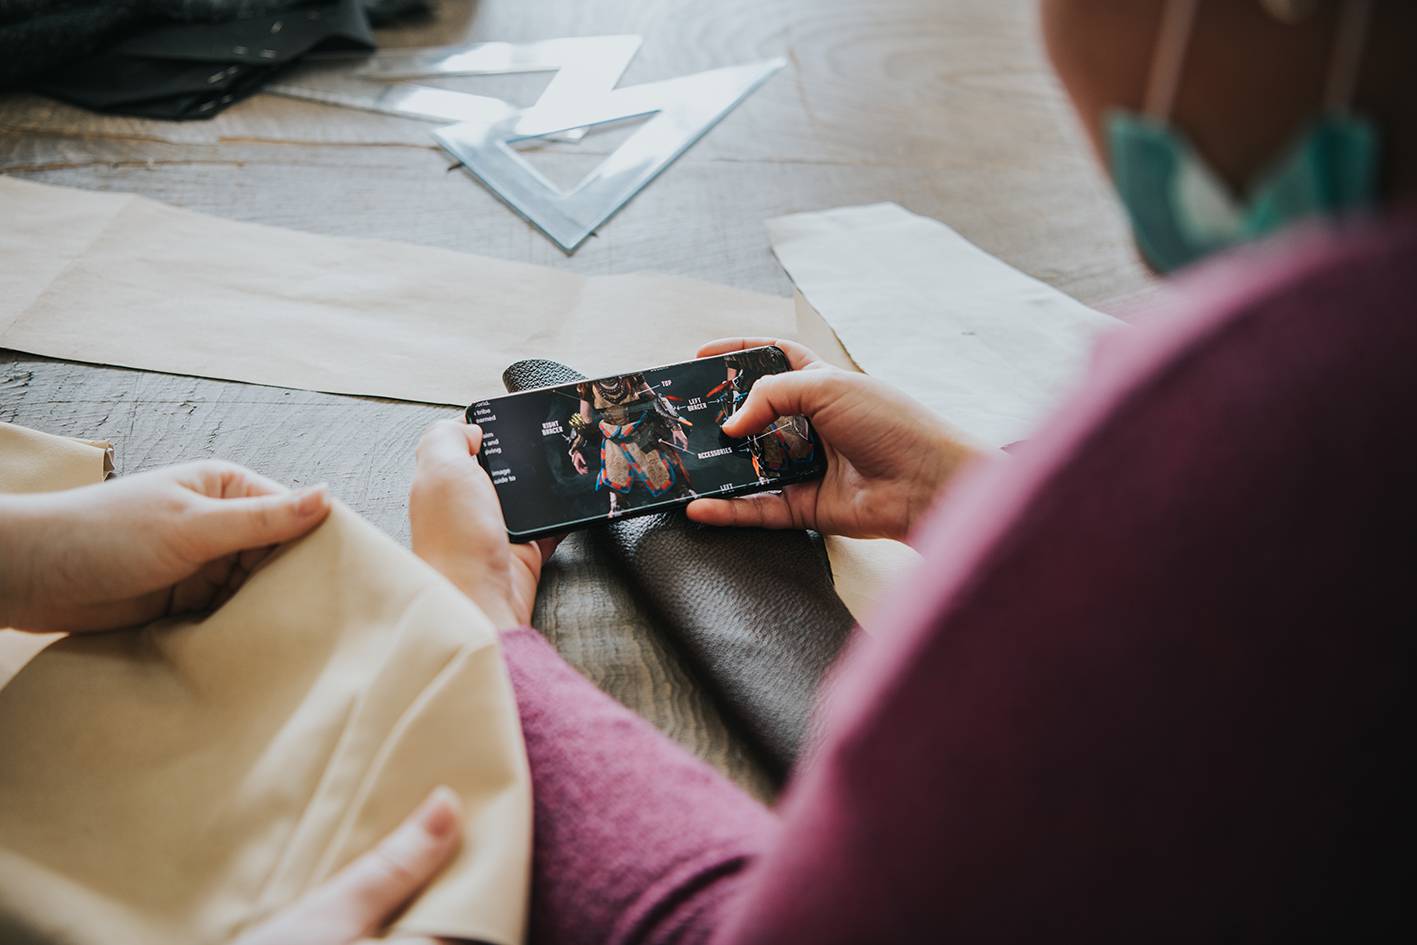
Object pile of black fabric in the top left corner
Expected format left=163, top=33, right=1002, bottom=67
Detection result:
left=0, top=0, right=428, bottom=119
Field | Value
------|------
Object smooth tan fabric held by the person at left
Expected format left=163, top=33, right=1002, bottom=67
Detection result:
left=0, top=428, right=531, bottom=945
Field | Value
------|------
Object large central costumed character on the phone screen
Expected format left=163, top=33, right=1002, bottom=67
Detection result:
left=570, top=374, right=694, bottom=516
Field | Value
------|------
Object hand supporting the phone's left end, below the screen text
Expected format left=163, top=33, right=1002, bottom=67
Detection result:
left=408, top=419, right=555, bottom=630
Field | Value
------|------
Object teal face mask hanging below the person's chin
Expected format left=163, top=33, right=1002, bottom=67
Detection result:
left=1105, top=111, right=1379, bottom=272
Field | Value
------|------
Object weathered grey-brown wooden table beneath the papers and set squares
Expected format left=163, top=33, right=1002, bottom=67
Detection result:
left=0, top=0, right=1148, bottom=796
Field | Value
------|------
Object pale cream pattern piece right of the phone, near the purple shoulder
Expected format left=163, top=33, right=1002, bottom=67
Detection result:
left=768, top=204, right=1122, bottom=448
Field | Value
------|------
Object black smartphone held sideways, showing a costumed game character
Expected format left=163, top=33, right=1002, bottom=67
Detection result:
left=468, top=346, right=826, bottom=541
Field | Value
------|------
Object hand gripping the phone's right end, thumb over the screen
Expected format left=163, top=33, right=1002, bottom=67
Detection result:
left=687, top=339, right=976, bottom=540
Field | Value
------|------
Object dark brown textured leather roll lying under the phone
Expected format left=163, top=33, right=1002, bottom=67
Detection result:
left=502, top=360, right=854, bottom=778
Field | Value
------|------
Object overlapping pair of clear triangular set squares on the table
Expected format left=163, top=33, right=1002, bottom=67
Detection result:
left=266, top=35, right=786, bottom=254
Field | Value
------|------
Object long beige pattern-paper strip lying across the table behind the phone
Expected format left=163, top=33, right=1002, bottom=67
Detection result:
left=0, top=177, right=796, bottom=407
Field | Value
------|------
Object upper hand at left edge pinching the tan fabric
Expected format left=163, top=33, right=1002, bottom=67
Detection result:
left=0, top=460, right=330, bottom=630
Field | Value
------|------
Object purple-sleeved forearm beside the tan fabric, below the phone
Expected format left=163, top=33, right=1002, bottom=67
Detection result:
left=502, top=629, right=777, bottom=945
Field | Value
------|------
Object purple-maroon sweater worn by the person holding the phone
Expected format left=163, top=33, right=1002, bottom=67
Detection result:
left=493, top=215, right=1417, bottom=945
